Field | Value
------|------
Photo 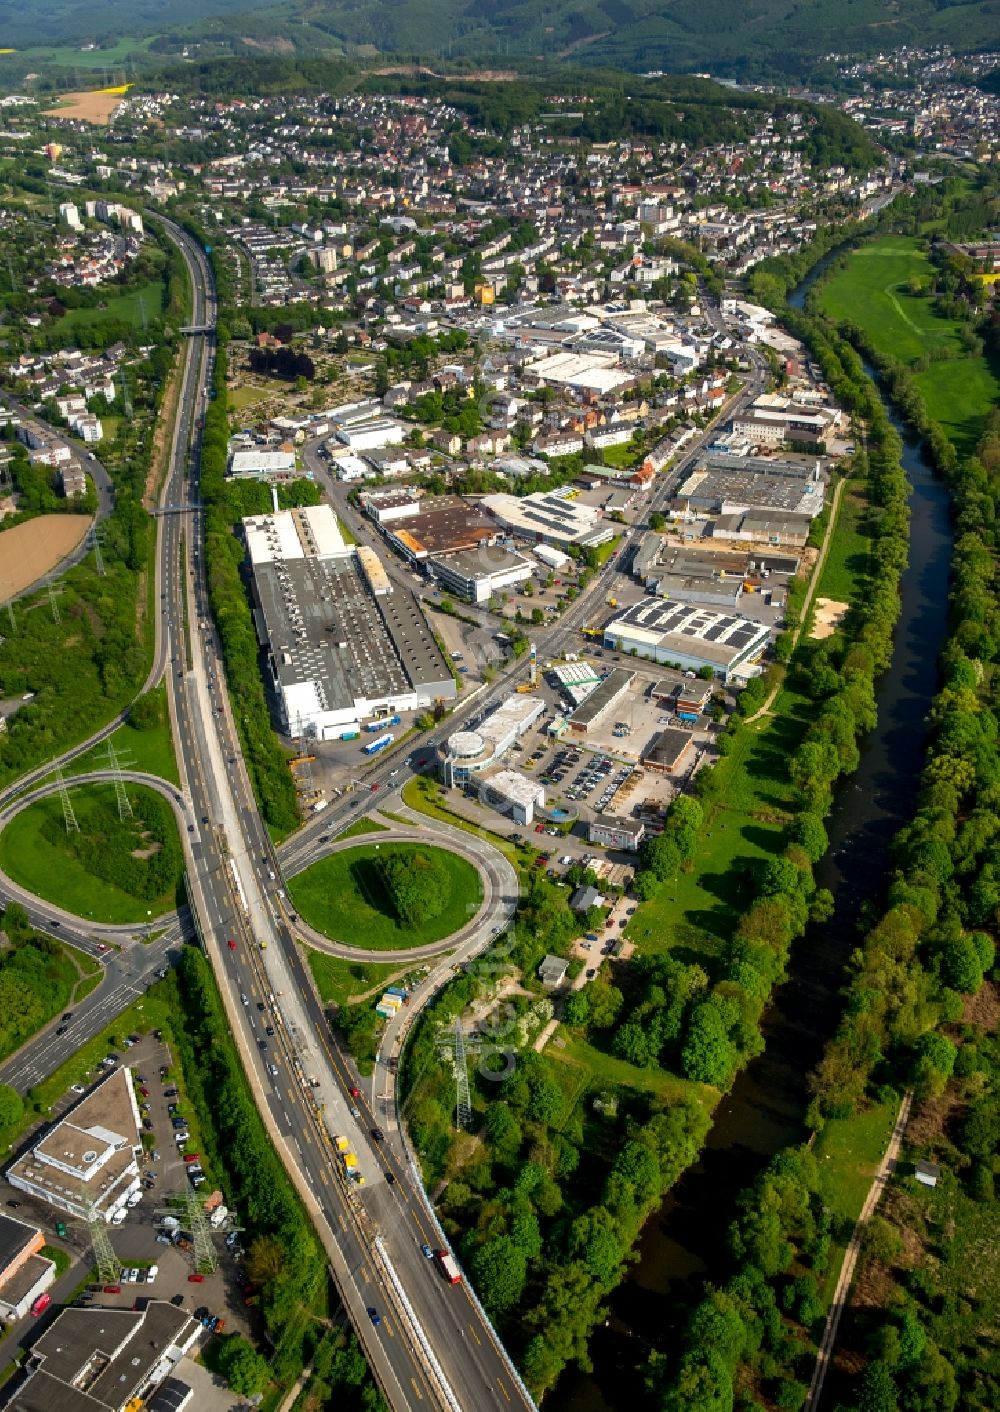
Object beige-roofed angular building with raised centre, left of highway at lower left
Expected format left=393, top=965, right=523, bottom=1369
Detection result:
left=7, top=1069, right=143, bottom=1225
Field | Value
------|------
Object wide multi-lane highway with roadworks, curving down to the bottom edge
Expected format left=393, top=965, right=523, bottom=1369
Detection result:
left=149, top=225, right=532, bottom=1412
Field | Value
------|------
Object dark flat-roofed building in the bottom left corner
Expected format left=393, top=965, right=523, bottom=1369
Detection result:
left=0, top=1299, right=202, bottom=1412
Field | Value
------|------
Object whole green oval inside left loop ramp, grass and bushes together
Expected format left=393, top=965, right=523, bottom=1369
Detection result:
left=0, top=785, right=184, bottom=925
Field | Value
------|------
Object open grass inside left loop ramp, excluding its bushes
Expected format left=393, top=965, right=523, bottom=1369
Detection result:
left=0, top=785, right=181, bottom=925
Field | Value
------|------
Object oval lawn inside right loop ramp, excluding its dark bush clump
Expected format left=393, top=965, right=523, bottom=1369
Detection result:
left=288, top=843, right=483, bottom=950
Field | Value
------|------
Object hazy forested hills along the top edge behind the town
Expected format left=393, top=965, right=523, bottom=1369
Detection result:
left=0, top=0, right=997, bottom=78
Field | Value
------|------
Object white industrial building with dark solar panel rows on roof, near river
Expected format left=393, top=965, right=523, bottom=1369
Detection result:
left=605, top=599, right=770, bottom=682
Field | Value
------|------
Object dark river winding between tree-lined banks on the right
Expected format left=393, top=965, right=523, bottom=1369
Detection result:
left=547, top=256, right=952, bottom=1412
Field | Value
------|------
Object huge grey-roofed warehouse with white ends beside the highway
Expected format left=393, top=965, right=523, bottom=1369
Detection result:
left=243, top=505, right=456, bottom=740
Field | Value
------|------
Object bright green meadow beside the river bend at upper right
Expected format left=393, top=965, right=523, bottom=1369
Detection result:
left=819, top=236, right=1000, bottom=451
